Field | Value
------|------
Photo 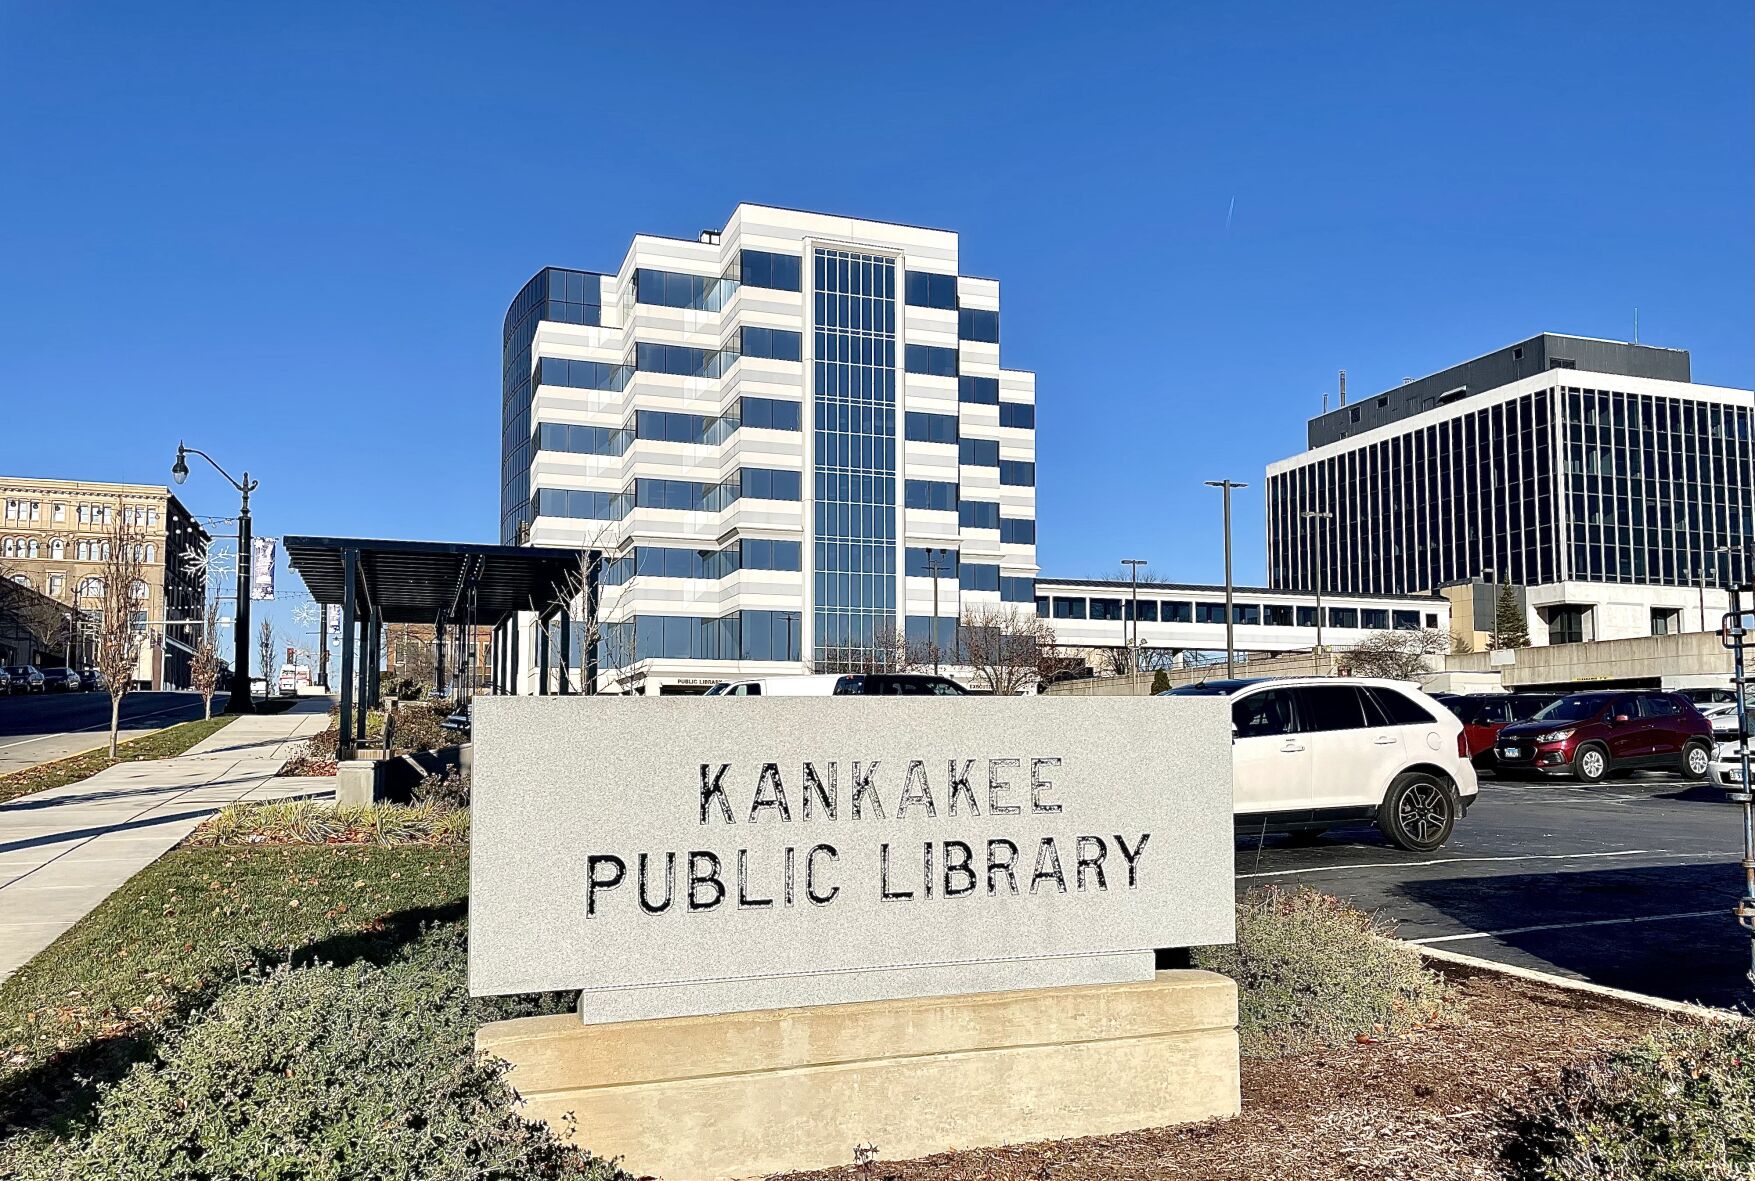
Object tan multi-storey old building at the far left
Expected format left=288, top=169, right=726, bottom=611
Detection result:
left=0, top=476, right=209, bottom=690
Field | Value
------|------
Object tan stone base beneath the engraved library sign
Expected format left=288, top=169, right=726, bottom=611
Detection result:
left=476, top=970, right=1239, bottom=1181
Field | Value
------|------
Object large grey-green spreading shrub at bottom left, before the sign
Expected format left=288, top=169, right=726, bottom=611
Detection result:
left=5, top=925, right=625, bottom=1181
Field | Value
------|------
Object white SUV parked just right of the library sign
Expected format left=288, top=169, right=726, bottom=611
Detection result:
left=1171, top=677, right=1479, bottom=853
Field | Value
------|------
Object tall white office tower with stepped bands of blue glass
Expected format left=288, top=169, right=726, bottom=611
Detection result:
left=500, top=205, right=1037, bottom=693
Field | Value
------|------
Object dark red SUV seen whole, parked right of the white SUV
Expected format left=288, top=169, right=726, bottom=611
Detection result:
left=1494, top=691, right=1713, bottom=783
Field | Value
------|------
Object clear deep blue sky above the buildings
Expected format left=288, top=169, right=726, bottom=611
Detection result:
left=0, top=0, right=1755, bottom=645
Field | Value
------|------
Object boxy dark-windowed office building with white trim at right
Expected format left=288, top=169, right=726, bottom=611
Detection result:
left=1267, top=335, right=1755, bottom=644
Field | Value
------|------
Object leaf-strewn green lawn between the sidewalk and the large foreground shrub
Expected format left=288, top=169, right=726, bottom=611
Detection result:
left=0, top=846, right=469, bottom=1144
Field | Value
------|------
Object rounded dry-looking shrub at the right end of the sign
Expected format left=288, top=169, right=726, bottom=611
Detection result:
left=1195, top=886, right=1444, bottom=1058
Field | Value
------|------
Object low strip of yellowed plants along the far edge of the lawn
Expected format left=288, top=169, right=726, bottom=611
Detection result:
left=190, top=800, right=469, bottom=844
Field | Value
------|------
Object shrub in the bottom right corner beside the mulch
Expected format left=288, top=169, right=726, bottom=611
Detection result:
left=1506, top=1021, right=1755, bottom=1181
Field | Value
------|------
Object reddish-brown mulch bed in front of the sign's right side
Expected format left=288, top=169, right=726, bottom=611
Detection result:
left=786, top=965, right=1662, bottom=1181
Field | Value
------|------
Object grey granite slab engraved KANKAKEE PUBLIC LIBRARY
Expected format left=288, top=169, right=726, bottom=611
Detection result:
left=469, top=697, right=1234, bottom=1021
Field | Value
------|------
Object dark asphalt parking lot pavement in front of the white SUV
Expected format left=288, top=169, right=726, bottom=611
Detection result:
left=1237, top=774, right=1755, bottom=1007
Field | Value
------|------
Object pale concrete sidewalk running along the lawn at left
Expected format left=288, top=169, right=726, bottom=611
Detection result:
left=0, top=697, right=333, bottom=979
